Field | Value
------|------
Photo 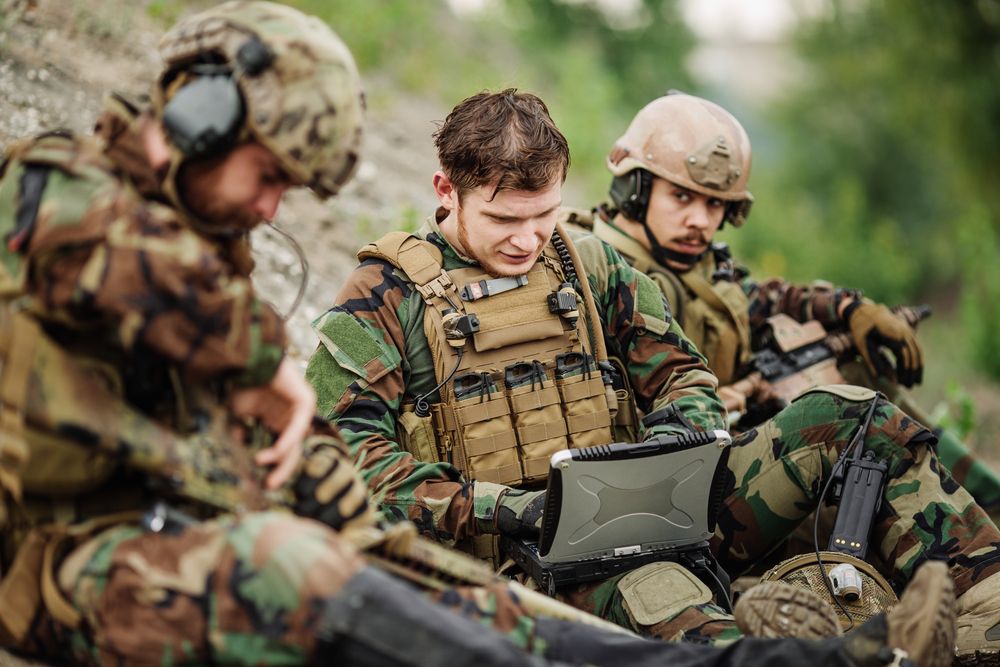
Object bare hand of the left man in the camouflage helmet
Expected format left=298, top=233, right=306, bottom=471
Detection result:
left=231, top=357, right=316, bottom=489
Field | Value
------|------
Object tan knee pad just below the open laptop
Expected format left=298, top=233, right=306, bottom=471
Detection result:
left=618, top=561, right=712, bottom=627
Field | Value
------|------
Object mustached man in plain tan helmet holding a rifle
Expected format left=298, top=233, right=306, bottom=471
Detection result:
left=567, top=94, right=1000, bottom=511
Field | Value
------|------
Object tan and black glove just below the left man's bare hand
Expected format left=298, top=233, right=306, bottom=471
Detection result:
left=292, top=422, right=375, bottom=531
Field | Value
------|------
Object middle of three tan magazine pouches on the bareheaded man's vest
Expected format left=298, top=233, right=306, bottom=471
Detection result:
left=507, top=380, right=569, bottom=482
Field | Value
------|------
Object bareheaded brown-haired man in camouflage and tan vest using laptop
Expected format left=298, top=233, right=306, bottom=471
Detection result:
left=307, top=91, right=1000, bottom=656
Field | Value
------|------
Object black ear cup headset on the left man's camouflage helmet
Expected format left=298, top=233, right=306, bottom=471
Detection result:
left=163, top=35, right=274, bottom=158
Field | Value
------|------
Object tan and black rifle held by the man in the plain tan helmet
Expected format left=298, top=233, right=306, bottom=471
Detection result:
left=726, top=305, right=931, bottom=428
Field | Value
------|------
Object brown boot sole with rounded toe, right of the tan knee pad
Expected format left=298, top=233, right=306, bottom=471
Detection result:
left=733, top=581, right=842, bottom=639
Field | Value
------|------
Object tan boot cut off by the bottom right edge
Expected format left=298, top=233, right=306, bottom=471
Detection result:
left=955, top=574, right=1000, bottom=667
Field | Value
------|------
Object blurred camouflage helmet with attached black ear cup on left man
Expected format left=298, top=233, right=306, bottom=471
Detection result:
left=153, top=0, right=364, bottom=230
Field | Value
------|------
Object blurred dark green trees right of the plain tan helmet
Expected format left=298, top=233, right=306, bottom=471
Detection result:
left=731, top=0, right=1000, bottom=378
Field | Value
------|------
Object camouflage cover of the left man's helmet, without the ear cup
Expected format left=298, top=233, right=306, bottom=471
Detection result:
left=160, top=0, right=364, bottom=197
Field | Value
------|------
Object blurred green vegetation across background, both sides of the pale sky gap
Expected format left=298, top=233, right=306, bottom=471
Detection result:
left=147, top=0, right=1000, bottom=392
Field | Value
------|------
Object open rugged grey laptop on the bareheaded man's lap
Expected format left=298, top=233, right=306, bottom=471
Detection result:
left=501, top=431, right=731, bottom=593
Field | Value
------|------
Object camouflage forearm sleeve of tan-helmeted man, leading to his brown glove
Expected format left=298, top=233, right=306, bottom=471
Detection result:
left=743, top=277, right=860, bottom=330
